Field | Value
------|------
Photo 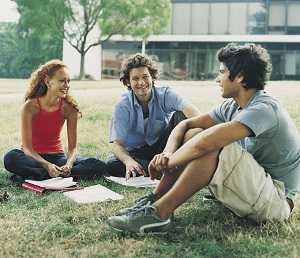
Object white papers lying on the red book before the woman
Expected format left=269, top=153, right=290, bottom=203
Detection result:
left=25, top=177, right=76, bottom=190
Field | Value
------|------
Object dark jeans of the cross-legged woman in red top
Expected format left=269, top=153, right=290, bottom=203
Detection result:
left=4, top=149, right=107, bottom=180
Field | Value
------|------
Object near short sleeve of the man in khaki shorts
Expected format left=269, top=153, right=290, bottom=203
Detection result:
left=233, top=103, right=278, bottom=136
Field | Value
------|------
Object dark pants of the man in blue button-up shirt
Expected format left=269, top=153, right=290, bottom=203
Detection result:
left=107, top=111, right=186, bottom=177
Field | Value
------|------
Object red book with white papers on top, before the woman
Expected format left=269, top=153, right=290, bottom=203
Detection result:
left=22, top=177, right=81, bottom=194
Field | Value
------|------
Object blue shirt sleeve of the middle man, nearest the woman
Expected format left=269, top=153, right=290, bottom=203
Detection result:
left=109, top=105, right=130, bottom=143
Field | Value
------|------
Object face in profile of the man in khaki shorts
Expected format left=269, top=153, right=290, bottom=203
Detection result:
left=216, top=63, right=241, bottom=98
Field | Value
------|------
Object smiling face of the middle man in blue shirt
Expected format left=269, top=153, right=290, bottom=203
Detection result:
left=129, top=67, right=152, bottom=101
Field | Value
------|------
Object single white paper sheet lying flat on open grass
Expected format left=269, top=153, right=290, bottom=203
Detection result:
left=64, top=185, right=124, bottom=203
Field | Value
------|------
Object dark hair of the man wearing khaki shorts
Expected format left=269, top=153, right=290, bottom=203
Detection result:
left=217, top=43, right=272, bottom=90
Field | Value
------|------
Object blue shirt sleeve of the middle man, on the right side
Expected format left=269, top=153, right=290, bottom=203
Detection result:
left=164, top=87, right=187, bottom=113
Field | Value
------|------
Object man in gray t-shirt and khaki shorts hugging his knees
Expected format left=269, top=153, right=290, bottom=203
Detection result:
left=109, top=44, right=300, bottom=233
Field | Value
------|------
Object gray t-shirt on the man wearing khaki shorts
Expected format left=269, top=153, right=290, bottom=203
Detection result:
left=209, top=91, right=300, bottom=200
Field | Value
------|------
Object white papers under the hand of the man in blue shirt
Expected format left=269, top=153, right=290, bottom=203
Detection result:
left=105, top=176, right=159, bottom=188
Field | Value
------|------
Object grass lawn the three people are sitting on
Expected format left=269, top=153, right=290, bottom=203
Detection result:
left=0, top=80, right=300, bottom=258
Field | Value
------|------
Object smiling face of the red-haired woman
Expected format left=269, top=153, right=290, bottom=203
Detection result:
left=47, top=67, right=70, bottom=98
